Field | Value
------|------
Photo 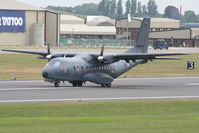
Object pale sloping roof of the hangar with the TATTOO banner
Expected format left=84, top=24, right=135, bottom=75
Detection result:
left=0, top=0, right=45, bottom=11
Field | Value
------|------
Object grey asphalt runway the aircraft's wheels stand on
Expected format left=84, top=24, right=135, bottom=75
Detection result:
left=0, top=77, right=199, bottom=103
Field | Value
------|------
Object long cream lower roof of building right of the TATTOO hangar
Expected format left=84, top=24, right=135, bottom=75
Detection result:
left=61, top=24, right=116, bottom=35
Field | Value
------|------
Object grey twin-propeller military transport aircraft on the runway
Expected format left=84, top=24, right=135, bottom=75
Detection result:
left=2, top=18, right=185, bottom=87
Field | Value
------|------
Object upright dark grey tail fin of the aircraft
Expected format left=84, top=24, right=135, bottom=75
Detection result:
left=126, top=18, right=151, bottom=53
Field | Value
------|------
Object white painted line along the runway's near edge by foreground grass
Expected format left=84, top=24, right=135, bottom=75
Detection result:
left=0, top=96, right=199, bottom=103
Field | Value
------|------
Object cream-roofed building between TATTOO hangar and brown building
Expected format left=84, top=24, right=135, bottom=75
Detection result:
left=60, top=13, right=116, bottom=39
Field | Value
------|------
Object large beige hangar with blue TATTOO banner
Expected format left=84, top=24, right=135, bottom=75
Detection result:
left=0, top=0, right=60, bottom=46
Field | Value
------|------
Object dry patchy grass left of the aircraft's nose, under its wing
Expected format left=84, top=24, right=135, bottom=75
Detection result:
left=0, top=54, right=47, bottom=80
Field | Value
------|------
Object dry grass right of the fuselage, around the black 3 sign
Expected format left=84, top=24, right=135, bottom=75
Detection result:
left=123, top=54, right=199, bottom=77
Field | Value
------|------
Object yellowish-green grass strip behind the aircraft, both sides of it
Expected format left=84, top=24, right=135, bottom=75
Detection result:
left=0, top=54, right=199, bottom=80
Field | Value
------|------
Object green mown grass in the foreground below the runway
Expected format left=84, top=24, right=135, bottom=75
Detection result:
left=0, top=100, right=199, bottom=133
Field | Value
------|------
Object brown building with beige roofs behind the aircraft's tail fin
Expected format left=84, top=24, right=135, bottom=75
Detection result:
left=116, top=18, right=199, bottom=47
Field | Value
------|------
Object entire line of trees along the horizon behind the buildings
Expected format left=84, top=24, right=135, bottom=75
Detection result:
left=47, top=0, right=199, bottom=23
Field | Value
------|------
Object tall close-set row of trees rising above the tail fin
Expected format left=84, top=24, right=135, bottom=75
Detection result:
left=98, top=0, right=159, bottom=18
